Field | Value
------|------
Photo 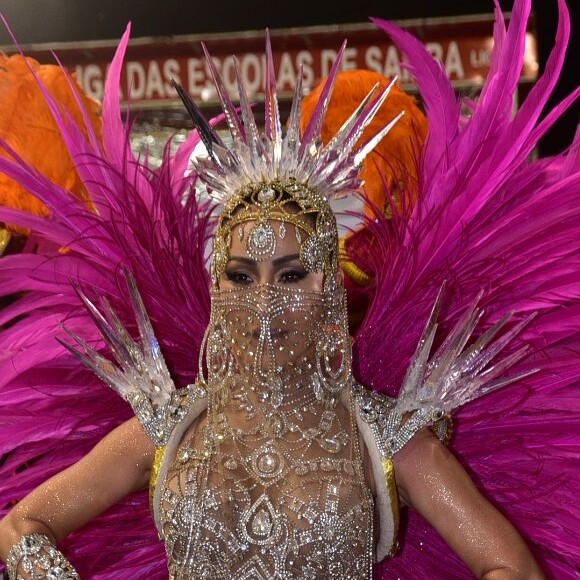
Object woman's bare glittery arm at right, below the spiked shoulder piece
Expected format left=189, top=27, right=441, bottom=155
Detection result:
left=394, top=429, right=544, bottom=580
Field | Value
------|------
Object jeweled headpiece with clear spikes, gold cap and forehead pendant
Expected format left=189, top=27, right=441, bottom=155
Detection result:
left=175, top=31, right=403, bottom=284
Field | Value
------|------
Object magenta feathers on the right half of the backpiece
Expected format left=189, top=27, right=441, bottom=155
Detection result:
left=354, top=0, right=580, bottom=579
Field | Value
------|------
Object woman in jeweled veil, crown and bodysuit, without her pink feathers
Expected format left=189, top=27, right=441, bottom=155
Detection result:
left=2, top=26, right=542, bottom=578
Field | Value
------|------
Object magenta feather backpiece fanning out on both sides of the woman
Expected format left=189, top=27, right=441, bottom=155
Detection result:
left=0, top=0, right=580, bottom=579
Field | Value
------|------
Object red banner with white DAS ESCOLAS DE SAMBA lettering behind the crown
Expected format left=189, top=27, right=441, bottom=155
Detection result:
left=5, top=17, right=538, bottom=108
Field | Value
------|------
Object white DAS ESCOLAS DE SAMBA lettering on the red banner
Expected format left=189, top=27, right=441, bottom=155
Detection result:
left=75, top=40, right=476, bottom=103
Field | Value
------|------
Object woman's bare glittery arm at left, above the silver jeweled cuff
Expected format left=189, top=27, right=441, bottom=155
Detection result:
left=0, top=418, right=155, bottom=561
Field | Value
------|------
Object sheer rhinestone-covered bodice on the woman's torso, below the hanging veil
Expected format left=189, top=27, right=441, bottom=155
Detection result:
left=160, top=390, right=373, bottom=579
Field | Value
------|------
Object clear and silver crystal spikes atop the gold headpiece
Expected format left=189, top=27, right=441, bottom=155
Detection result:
left=176, top=31, right=404, bottom=204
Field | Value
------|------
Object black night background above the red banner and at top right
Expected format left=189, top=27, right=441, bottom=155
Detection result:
left=0, top=0, right=580, bottom=155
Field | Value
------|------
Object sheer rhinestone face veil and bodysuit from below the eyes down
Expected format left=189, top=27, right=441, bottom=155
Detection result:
left=159, top=285, right=373, bottom=579
